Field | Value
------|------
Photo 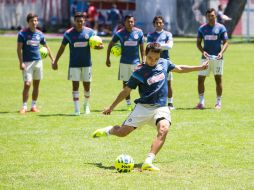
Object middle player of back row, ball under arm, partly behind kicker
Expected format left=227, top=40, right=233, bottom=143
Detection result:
left=106, top=15, right=145, bottom=111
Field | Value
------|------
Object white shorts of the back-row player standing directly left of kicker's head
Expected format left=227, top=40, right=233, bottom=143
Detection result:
left=118, top=63, right=137, bottom=81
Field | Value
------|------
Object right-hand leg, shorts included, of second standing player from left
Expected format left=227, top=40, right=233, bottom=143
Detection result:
left=81, top=67, right=92, bottom=114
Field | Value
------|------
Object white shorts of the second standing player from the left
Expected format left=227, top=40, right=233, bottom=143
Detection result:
left=68, top=67, right=92, bottom=82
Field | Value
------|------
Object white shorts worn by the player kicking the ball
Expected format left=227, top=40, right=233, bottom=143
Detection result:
left=123, top=104, right=171, bottom=127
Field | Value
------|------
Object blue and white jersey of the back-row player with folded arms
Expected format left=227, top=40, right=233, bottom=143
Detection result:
left=147, top=30, right=173, bottom=59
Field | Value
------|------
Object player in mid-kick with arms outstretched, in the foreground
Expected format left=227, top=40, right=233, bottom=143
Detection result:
left=92, top=43, right=208, bottom=171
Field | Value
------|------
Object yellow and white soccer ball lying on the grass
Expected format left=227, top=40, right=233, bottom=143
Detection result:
left=115, top=154, right=134, bottom=173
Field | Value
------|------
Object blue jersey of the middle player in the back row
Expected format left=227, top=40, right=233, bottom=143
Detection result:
left=112, top=27, right=144, bottom=64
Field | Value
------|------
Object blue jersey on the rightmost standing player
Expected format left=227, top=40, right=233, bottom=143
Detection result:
left=197, top=23, right=228, bottom=58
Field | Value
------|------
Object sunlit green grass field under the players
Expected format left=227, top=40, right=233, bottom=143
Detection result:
left=0, top=36, right=254, bottom=190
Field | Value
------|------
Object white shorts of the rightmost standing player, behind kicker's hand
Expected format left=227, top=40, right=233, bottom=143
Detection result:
left=198, top=59, right=224, bottom=76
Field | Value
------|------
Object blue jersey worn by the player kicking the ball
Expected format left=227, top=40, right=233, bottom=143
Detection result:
left=127, top=58, right=175, bottom=107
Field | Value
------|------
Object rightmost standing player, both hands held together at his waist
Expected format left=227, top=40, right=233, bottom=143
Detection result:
left=196, top=8, right=228, bottom=110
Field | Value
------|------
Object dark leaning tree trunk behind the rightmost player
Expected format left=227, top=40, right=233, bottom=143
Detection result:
left=224, top=0, right=247, bottom=38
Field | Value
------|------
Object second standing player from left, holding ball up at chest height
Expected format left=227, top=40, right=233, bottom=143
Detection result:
left=54, top=12, right=103, bottom=116
